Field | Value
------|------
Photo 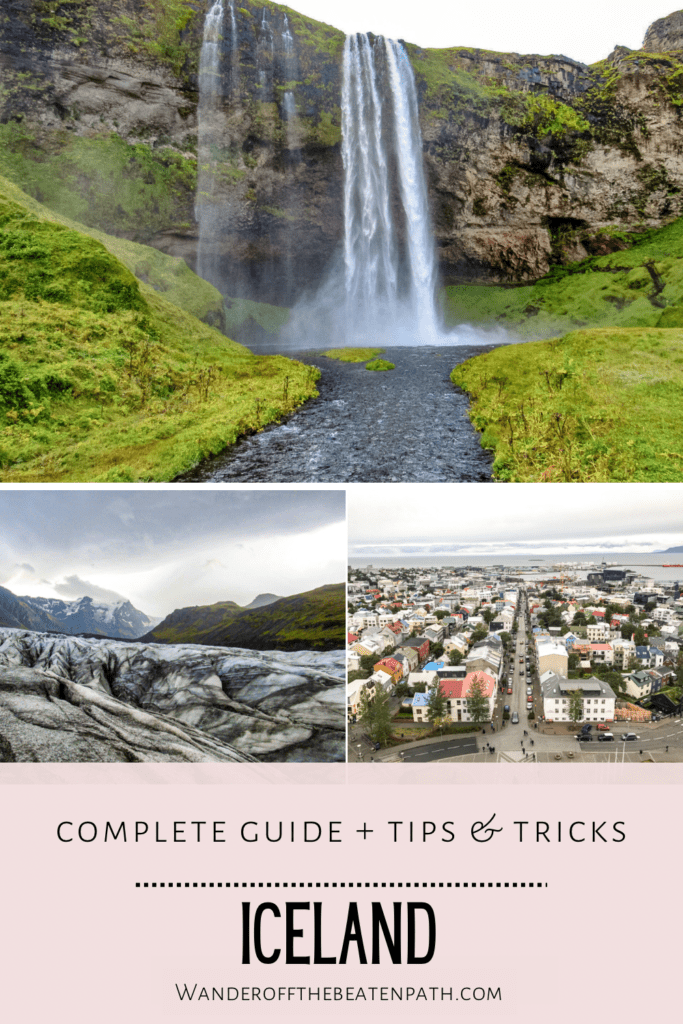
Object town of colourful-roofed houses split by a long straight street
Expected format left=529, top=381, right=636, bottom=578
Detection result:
left=347, top=556, right=683, bottom=763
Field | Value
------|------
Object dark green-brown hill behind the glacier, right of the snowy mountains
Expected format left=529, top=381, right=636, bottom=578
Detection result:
left=140, top=583, right=346, bottom=650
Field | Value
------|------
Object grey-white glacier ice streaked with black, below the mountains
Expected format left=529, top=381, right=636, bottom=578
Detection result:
left=0, top=629, right=345, bottom=762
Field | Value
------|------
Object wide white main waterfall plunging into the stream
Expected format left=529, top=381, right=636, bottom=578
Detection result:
left=342, top=34, right=442, bottom=344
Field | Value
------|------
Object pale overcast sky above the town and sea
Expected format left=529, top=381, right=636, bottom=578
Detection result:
left=348, top=483, right=683, bottom=564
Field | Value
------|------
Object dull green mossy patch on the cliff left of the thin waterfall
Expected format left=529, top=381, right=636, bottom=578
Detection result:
left=0, top=122, right=197, bottom=242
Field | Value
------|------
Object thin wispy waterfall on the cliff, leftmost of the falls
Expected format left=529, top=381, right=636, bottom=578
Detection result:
left=195, top=0, right=225, bottom=283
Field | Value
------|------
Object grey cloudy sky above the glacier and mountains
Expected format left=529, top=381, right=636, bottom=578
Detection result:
left=0, top=487, right=346, bottom=616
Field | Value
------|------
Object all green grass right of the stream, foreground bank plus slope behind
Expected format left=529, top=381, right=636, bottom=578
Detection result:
left=444, top=210, right=683, bottom=481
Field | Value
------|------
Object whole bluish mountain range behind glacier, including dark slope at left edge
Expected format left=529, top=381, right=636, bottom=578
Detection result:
left=0, top=587, right=159, bottom=640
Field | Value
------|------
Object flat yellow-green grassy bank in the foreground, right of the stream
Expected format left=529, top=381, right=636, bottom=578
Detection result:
left=451, top=328, right=683, bottom=482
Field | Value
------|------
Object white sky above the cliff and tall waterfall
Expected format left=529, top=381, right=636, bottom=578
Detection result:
left=288, top=0, right=678, bottom=63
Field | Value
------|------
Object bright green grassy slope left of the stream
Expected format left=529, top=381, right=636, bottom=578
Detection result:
left=0, top=179, right=317, bottom=482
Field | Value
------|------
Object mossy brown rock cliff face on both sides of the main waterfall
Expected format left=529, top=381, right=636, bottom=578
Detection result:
left=0, top=0, right=683, bottom=303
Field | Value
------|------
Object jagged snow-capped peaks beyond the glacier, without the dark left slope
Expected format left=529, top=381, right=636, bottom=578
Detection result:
left=18, top=597, right=161, bottom=640
